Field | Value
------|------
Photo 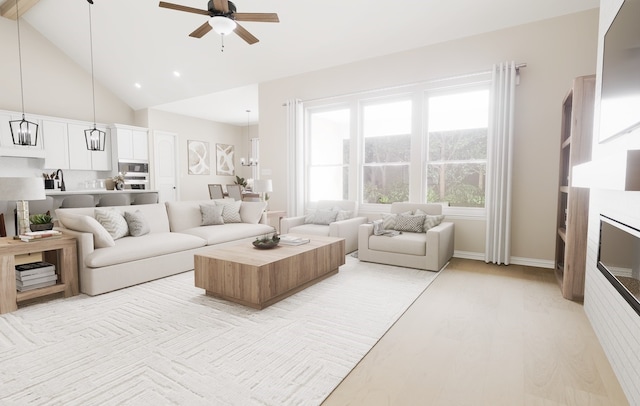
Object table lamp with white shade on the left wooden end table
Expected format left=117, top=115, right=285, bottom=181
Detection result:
left=0, top=178, right=46, bottom=234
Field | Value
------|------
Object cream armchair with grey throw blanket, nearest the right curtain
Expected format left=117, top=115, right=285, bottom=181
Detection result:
left=358, top=203, right=454, bottom=271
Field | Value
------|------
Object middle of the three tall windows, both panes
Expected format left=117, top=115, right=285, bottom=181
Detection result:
left=362, top=100, right=412, bottom=203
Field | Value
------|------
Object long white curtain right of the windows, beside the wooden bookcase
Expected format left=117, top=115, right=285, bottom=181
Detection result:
left=485, top=62, right=517, bottom=265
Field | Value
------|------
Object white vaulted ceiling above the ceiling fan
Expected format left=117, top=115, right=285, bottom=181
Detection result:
left=0, top=0, right=599, bottom=125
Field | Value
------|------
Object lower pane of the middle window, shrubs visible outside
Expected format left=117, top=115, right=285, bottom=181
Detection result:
left=362, top=165, right=409, bottom=203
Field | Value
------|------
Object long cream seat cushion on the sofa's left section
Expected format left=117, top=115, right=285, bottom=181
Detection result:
left=84, top=232, right=205, bottom=272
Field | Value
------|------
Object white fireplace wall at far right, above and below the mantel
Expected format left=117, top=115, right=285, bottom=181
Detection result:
left=584, top=0, right=640, bottom=405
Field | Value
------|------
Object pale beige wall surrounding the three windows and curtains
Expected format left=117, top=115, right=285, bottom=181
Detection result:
left=259, top=10, right=598, bottom=267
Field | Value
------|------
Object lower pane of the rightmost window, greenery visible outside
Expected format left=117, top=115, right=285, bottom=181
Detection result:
left=427, top=163, right=486, bottom=207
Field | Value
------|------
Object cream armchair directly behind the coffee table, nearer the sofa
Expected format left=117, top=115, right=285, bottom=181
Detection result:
left=280, top=200, right=368, bottom=253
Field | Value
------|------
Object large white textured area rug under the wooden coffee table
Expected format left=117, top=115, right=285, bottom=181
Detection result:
left=0, top=256, right=437, bottom=406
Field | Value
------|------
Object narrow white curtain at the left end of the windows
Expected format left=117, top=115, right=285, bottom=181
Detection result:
left=285, top=99, right=304, bottom=216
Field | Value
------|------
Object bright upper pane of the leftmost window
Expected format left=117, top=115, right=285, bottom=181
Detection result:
left=309, top=109, right=350, bottom=165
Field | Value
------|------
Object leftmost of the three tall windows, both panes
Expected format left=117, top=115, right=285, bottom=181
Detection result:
left=307, top=108, right=351, bottom=201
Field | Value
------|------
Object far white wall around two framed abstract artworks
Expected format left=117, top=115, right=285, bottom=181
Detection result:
left=145, top=109, right=255, bottom=200
